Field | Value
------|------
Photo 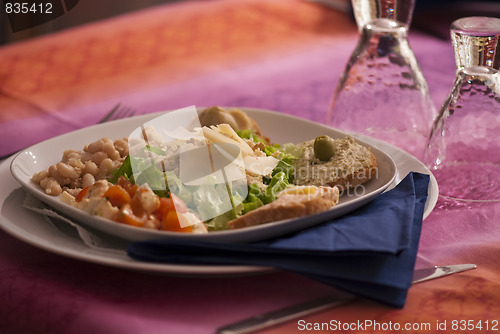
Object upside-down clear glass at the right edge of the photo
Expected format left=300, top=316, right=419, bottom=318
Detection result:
left=424, top=17, right=500, bottom=201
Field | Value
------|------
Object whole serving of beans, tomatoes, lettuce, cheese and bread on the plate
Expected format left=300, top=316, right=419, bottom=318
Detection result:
left=31, top=107, right=378, bottom=234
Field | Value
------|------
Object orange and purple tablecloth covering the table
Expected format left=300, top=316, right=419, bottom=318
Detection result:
left=0, top=0, right=500, bottom=334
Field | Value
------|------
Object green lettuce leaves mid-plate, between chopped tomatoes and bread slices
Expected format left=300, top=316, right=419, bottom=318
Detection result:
left=109, top=130, right=301, bottom=231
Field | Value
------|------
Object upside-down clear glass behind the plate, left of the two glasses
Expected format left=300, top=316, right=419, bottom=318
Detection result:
left=327, top=0, right=436, bottom=158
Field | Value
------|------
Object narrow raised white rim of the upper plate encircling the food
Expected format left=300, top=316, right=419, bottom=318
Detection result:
left=10, top=107, right=396, bottom=242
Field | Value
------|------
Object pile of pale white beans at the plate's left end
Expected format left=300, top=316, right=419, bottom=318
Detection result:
left=32, top=138, right=128, bottom=196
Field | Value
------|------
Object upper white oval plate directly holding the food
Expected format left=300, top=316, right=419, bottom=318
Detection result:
left=11, top=109, right=396, bottom=242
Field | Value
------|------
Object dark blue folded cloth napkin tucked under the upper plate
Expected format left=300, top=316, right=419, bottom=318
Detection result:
left=128, top=172, right=429, bottom=307
